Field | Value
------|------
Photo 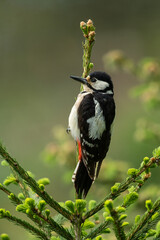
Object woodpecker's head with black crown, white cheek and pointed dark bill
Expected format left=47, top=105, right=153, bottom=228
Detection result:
left=70, top=72, right=114, bottom=95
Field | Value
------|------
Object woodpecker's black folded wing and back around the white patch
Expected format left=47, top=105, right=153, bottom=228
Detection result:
left=78, top=93, right=115, bottom=180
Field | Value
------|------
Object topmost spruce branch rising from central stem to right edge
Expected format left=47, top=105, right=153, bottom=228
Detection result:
left=83, top=156, right=160, bottom=220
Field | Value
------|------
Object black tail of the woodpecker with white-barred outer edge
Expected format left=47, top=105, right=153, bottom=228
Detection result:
left=72, top=160, right=94, bottom=198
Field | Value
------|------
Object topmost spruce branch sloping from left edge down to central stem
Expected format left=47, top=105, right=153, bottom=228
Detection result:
left=0, top=145, right=71, bottom=220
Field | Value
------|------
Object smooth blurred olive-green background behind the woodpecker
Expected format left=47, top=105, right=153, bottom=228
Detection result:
left=0, top=0, right=160, bottom=240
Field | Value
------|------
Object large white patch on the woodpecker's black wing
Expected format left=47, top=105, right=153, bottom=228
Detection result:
left=87, top=99, right=106, bottom=139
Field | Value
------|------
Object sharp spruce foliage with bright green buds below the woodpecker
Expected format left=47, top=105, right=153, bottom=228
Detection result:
left=0, top=143, right=160, bottom=240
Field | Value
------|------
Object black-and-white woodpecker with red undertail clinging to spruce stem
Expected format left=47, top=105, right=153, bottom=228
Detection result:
left=68, top=72, right=115, bottom=198
